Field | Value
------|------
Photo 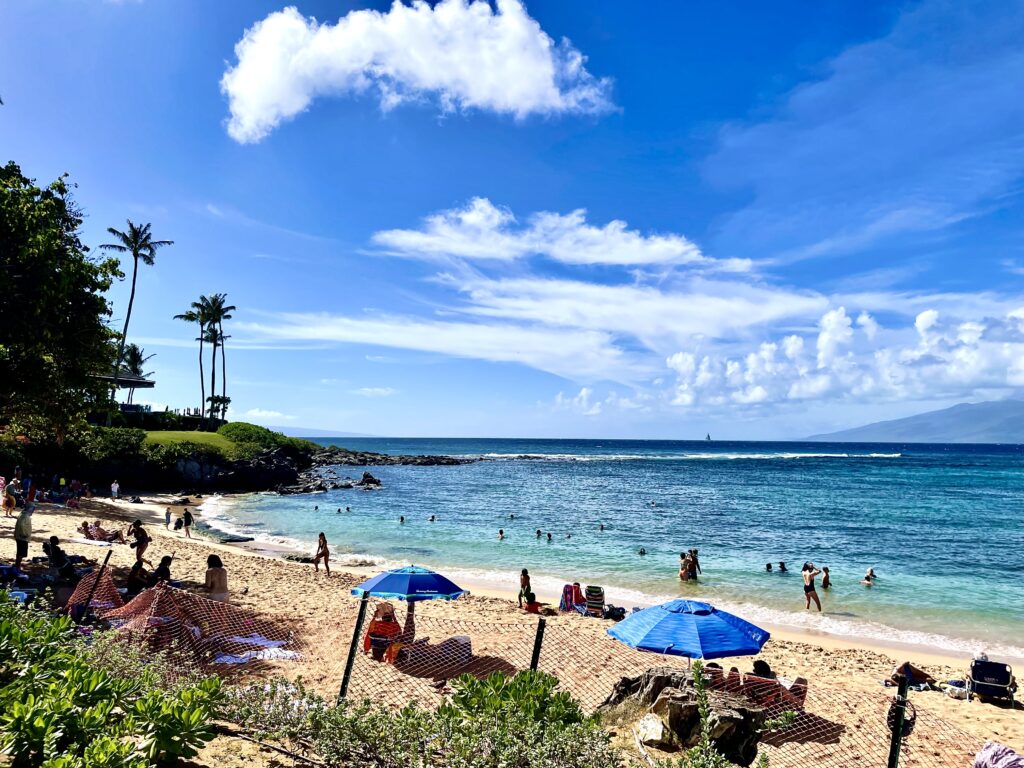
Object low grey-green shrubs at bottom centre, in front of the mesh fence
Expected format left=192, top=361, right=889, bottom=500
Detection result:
left=222, top=673, right=621, bottom=768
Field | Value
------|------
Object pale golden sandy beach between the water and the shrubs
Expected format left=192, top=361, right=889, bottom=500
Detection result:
left=0, top=496, right=1024, bottom=751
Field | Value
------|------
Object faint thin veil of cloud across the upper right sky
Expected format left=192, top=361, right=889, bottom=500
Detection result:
left=705, top=0, right=1024, bottom=260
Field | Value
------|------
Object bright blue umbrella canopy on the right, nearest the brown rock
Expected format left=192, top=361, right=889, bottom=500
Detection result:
left=608, top=600, right=770, bottom=658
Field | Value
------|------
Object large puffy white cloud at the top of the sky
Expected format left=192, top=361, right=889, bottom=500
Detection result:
left=220, top=0, right=611, bottom=142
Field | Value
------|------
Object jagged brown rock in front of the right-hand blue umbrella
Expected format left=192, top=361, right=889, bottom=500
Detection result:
left=602, top=667, right=765, bottom=766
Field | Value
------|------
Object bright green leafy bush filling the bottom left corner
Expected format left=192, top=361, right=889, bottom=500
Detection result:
left=0, top=593, right=222, bottom=768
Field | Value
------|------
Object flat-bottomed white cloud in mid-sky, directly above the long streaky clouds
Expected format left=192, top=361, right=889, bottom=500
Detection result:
left=373, top=198, right=751, bottom=271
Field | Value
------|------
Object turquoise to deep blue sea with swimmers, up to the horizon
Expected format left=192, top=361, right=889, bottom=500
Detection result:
left=197, top=438, right=1024, bottom=657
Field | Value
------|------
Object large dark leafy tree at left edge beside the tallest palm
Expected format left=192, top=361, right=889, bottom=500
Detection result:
left=0, top=163, right=122, bottom=443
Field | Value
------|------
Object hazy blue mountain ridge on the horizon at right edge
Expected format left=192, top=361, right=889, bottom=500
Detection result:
left=807, top=400, right=1024, bottom=443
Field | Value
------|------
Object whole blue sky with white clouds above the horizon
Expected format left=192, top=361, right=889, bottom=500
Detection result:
left=0, top=0, right=1024, bottom=438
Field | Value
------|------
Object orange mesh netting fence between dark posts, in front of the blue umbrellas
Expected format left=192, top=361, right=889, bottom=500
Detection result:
left=336, top=601, right=982, bottom=768
